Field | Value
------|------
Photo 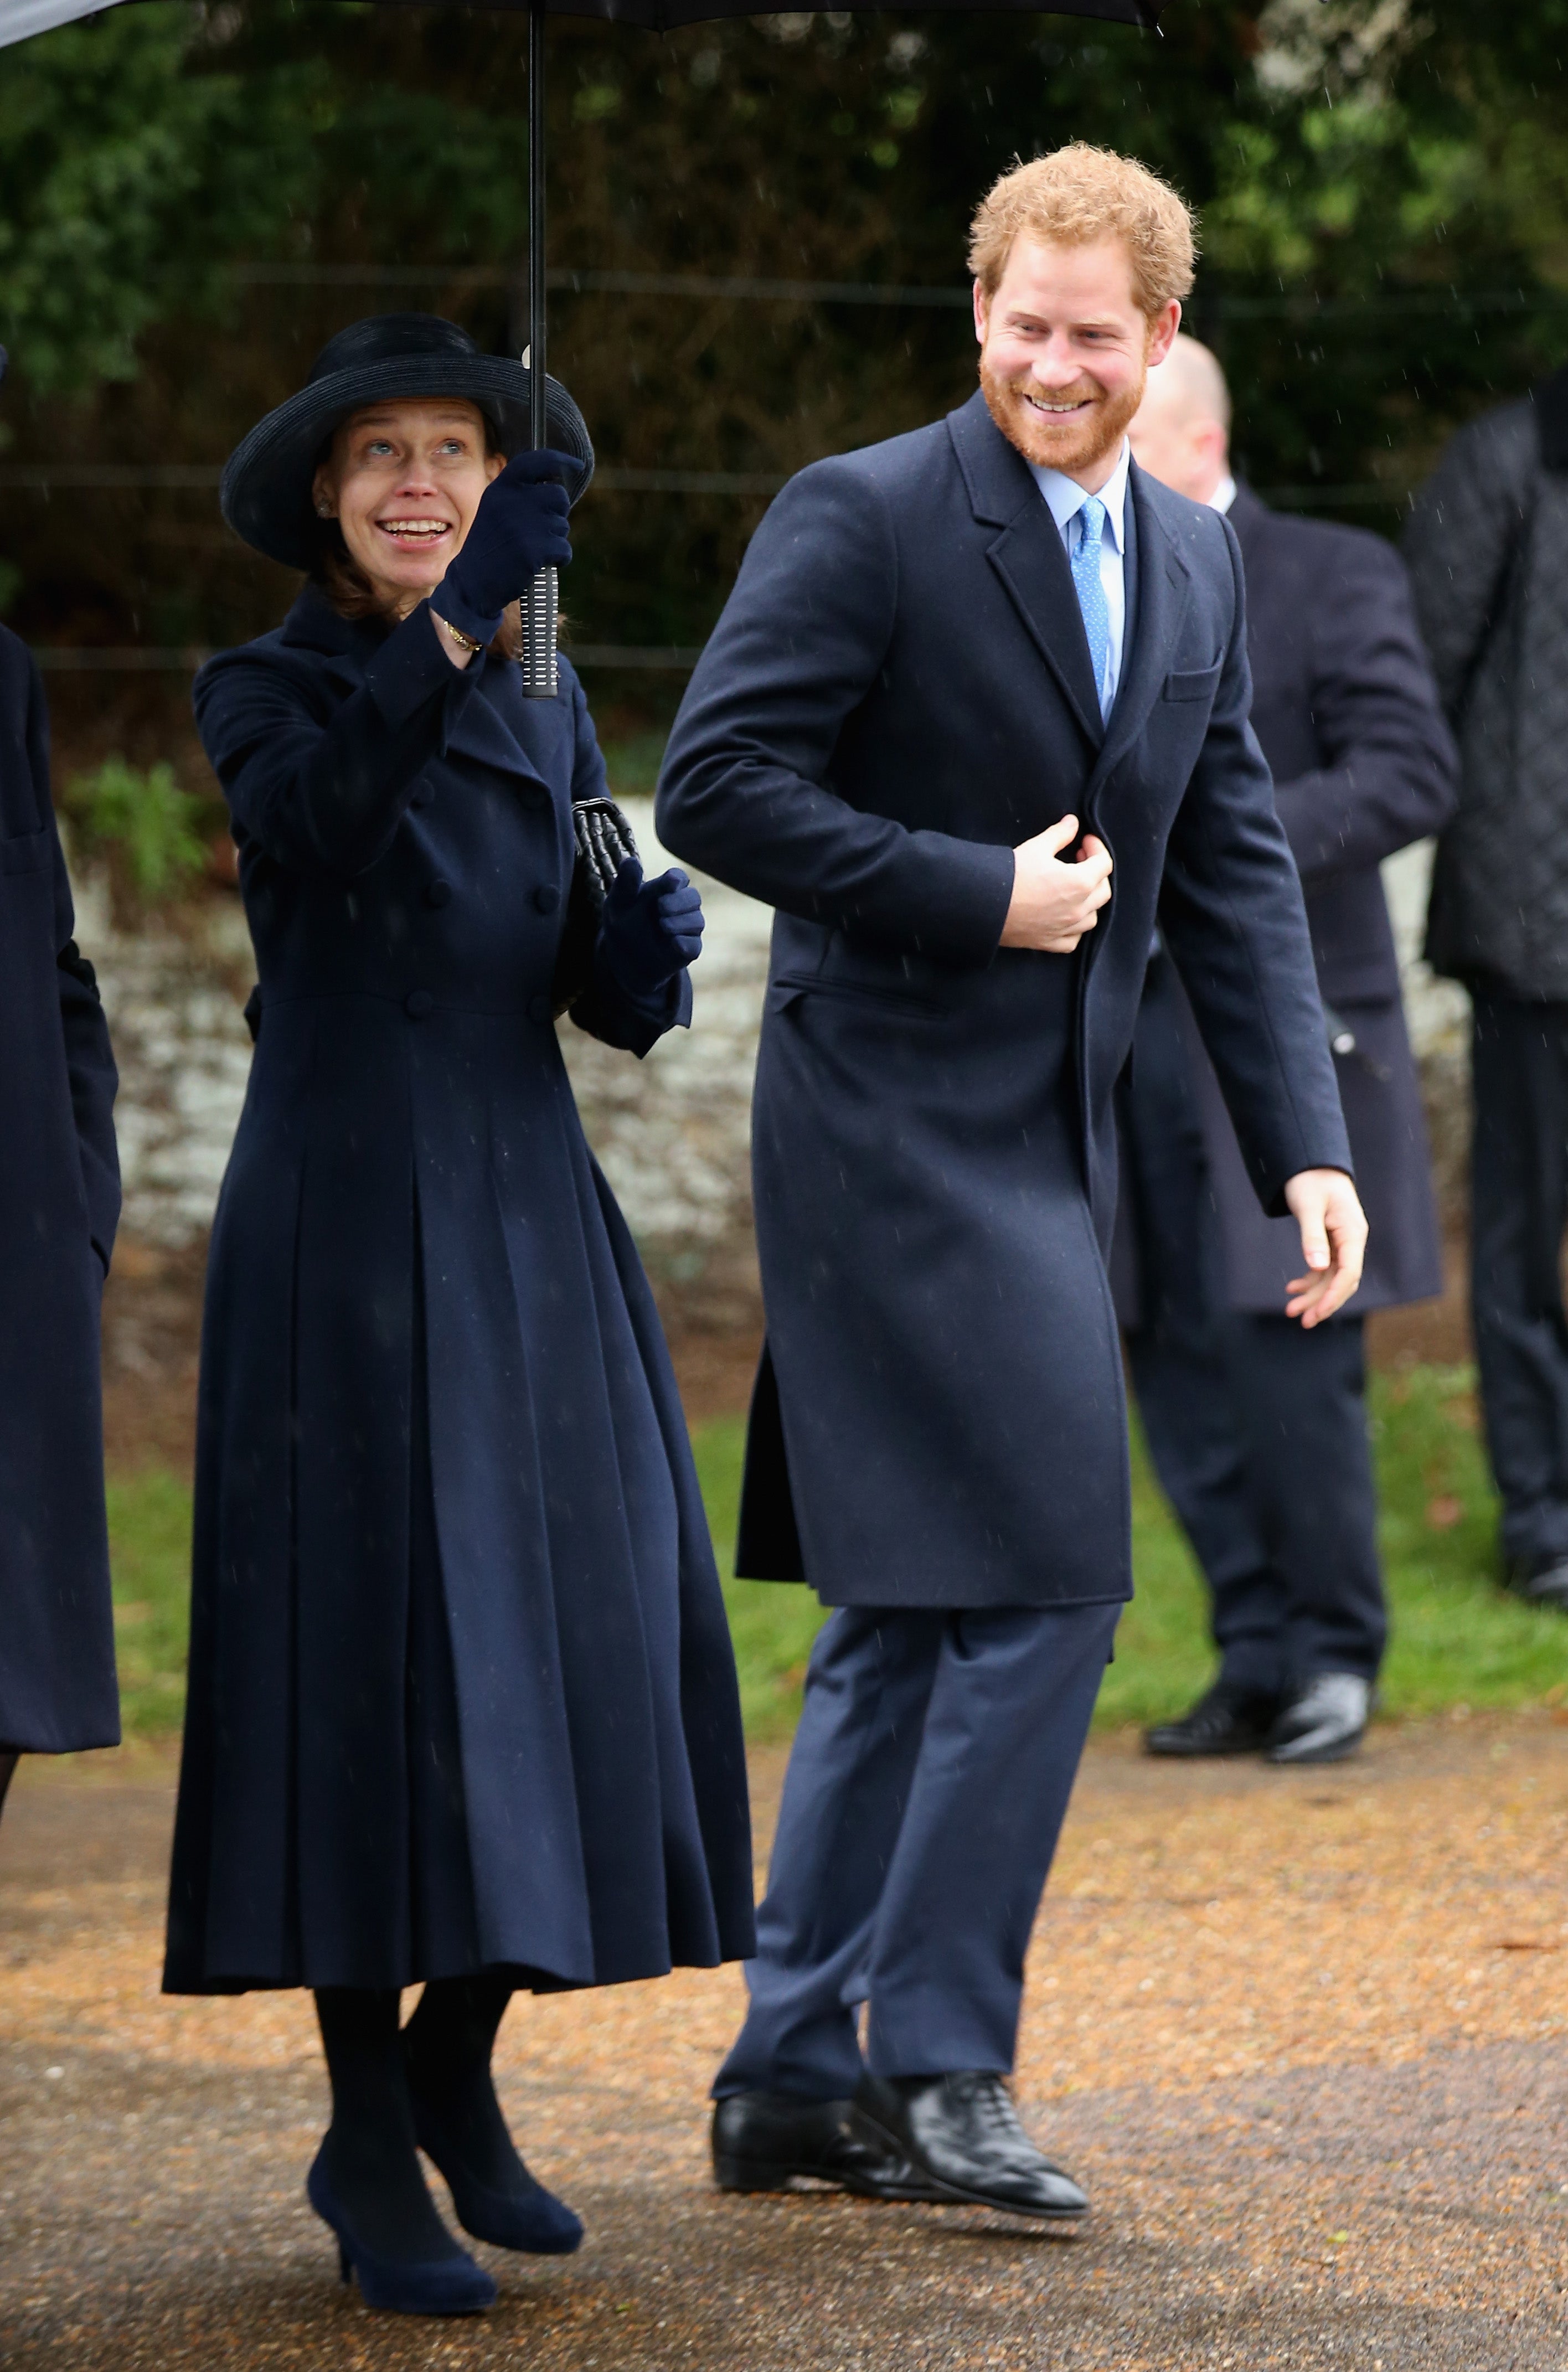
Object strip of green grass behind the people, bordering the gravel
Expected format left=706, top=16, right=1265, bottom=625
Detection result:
left=109, top=1367, right=1568, bottom=1739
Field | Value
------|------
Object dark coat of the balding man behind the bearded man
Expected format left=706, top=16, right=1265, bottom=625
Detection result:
left=1134, top=486, right=1459, bottom=1312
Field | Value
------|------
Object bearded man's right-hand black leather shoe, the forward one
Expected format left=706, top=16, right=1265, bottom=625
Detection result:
left=854, top=2073, right=1089, bottom=2215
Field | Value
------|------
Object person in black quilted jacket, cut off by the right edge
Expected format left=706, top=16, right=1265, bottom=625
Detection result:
left=1404, top=370, right=1568, bottom=1613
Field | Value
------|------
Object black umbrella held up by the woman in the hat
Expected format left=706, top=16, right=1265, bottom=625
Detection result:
left=0, top=0, right=1162, bottom=700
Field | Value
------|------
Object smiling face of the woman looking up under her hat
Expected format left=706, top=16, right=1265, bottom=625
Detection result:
left=313, top=396, right=506, bottom=617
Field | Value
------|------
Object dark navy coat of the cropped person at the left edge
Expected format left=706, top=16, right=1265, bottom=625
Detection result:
left=0, top=626, right=118, bottom=1755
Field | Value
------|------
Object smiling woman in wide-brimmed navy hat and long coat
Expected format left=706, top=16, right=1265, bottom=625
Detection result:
left=164, top=316, right=752, bottom=2313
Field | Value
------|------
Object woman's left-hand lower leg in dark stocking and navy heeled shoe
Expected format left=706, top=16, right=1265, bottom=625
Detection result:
left=306, top=1986, right=496, bottom=2315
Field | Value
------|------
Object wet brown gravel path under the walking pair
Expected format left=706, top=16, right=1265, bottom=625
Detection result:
left=0, top=1713, right=1568, bottom=2372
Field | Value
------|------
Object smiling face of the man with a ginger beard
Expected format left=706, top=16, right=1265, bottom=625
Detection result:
left=975, top=237, right=1182, bottom=493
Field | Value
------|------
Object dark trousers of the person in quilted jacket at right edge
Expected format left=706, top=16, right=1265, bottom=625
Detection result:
left=1471, top=996, right=1568, bottom=1563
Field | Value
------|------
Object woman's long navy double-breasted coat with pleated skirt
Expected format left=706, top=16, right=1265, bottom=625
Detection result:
left=166, top=591, right=752, bottom=1993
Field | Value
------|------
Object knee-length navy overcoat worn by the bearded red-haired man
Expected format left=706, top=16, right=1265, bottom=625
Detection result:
left=659, top=396, right=1350, bottom=1606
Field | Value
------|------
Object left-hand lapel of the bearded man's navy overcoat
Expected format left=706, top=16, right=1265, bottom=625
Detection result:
left=946, top=396, right=1106, bottom=750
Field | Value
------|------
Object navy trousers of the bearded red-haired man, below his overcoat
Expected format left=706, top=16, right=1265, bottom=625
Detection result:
left=714, top=1603, right=1122, bottom=2099
